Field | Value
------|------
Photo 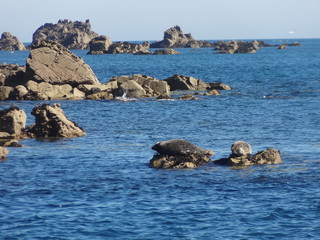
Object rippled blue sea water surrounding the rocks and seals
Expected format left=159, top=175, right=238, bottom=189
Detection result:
left=0, top=39, right=320, bottom=240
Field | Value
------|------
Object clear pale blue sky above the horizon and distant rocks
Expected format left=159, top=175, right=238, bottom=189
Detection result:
left=0, top=0, right=320, bottom=42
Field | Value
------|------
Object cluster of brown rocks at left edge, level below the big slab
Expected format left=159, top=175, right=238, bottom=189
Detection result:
left=0, top=104, right=85, bottom=147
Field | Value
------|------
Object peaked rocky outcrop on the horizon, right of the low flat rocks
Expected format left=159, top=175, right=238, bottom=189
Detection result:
left=150, top=26, right=213, bottom=48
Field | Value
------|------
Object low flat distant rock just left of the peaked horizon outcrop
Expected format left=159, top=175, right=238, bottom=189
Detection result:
left=106, top=42, right=151, bottom=55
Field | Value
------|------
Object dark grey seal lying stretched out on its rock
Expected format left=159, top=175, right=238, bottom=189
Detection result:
left=152, top=139, right=214, bottom=156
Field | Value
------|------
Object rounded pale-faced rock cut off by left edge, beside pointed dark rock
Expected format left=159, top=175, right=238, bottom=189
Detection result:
left=0, top=107, right=27, bottom=139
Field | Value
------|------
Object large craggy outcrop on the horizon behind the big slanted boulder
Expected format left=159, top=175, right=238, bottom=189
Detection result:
left=32, top=20, right=98, bottom=49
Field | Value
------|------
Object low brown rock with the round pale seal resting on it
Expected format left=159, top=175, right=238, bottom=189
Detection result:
left=214, top=141, right=282, bottom=167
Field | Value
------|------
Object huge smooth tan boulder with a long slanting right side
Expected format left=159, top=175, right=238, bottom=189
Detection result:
left=25, top=41, right=100, bottom=87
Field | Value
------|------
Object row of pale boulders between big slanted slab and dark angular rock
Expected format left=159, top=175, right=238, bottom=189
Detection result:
left=107, top=74, right=170, bottom=98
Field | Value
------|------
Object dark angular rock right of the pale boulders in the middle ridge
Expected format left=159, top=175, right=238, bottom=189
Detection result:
left=163, top=74, right=210, bottom=91
